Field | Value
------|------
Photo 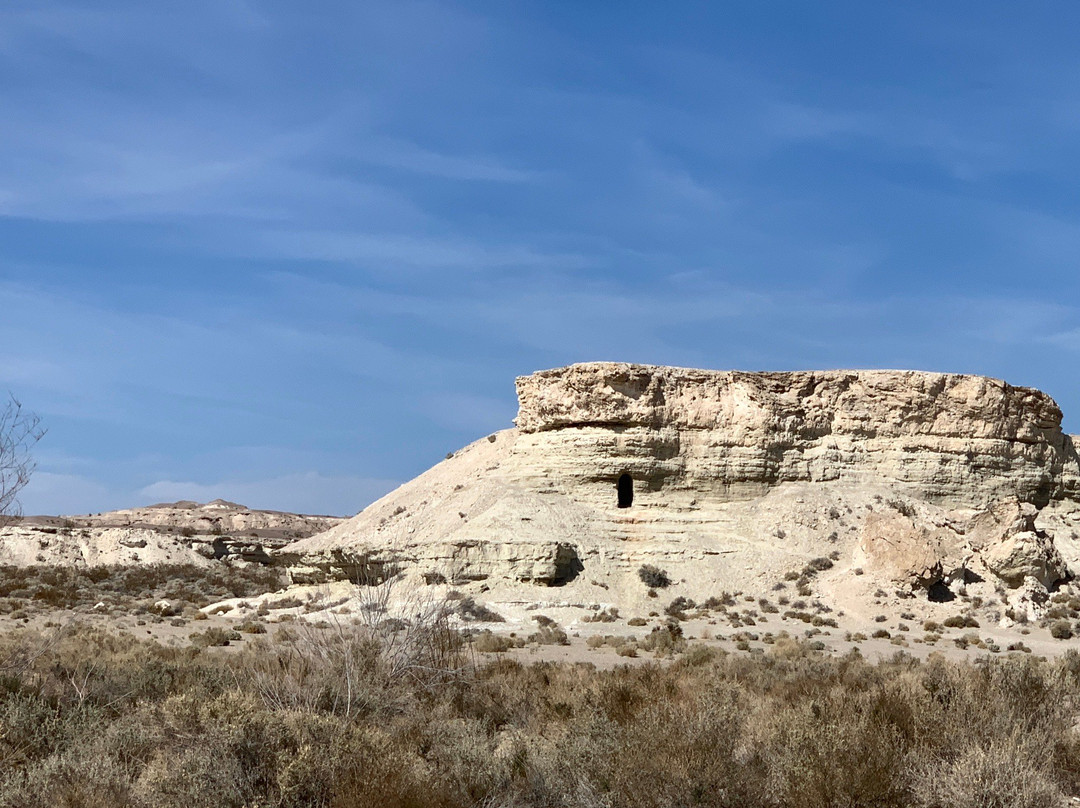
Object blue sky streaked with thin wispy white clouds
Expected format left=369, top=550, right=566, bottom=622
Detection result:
left=6, top=0, right=1080, bottom=513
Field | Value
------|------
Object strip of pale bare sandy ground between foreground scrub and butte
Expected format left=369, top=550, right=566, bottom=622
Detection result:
left=0, top=584, right=1080, bottom=669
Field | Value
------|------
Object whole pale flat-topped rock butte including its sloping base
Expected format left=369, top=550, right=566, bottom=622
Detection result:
left=279, top=362, right=1080, bottom=617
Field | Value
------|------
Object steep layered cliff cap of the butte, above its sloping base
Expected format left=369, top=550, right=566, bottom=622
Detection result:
left=514, top=362, right=1077, bottom=508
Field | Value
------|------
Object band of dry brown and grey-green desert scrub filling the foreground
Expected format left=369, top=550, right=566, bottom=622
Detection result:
left=6, top=604, right=1080, bottom=808
